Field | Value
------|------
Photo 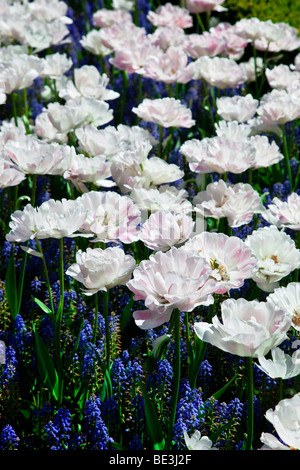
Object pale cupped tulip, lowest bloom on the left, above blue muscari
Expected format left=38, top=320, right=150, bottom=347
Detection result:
left=66, top=247, right=136, bottom=295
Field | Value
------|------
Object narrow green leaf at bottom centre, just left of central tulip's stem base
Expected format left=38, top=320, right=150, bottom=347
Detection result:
left=139, top=381, right=165, bottom=450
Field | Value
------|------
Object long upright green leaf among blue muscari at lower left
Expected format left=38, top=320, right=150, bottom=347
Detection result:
left=33, top=325, right=60, bottom=401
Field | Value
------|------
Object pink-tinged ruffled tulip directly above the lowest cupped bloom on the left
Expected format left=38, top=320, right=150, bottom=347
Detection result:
left=79, top=191, right=141, bottom=243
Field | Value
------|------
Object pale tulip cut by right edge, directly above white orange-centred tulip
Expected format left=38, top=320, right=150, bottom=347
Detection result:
left=262, top=193, right=300, bottom=231
